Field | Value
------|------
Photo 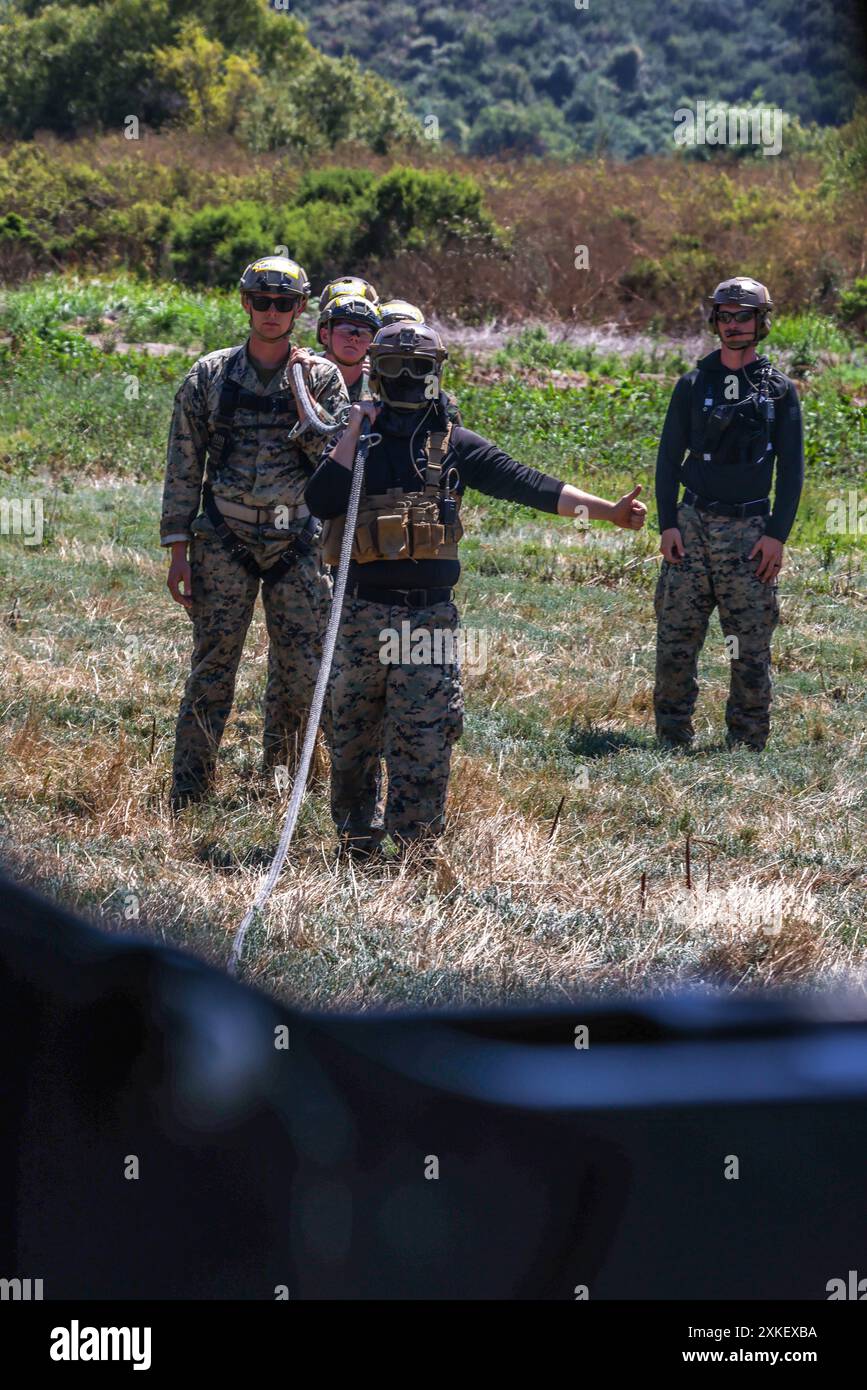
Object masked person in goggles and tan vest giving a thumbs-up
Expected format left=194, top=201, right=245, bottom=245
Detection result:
left=304, top=322, right=645, bottom=858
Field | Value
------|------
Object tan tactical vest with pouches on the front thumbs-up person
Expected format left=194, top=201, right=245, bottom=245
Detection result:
left=322, top=424, right=464, bottom=564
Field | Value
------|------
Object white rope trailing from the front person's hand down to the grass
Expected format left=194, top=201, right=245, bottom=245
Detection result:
left=228, top=418, right=371, bottom=974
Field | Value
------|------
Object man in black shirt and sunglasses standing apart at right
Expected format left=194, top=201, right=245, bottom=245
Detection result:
left=653, top=277, right=803, bottom=751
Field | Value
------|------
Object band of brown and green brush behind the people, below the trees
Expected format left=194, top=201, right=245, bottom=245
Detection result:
left=0, top=113, right=867, bottom=329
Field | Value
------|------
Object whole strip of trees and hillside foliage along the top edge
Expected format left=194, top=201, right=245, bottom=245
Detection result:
left=0, top=0, right=867, bottom=158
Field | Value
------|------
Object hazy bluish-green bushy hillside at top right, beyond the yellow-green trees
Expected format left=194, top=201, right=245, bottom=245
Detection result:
left=293, top=0, right=867, bottom=156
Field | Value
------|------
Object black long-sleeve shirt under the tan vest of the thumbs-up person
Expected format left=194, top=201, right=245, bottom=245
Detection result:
left=304, top=408, right=564, bottom=589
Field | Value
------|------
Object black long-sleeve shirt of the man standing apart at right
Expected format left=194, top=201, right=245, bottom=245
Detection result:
left=656, top=349, right=804, bottom=542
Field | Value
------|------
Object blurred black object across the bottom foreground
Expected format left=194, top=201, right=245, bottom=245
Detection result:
left=0, top=880, right=867, bottom=1300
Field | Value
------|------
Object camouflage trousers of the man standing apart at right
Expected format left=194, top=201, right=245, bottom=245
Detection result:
left=653, top=505, right=779, bottom=749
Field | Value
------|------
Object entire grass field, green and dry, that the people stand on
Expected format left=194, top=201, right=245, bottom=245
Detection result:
left=0, top=277, right=867, bottom=1008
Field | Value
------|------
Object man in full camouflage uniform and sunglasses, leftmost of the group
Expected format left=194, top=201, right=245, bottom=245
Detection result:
left=160, top=257, right=349, bottom=809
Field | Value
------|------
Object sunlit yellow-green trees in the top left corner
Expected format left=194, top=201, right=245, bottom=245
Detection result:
left=0, top=0, right=420, bottom=154
